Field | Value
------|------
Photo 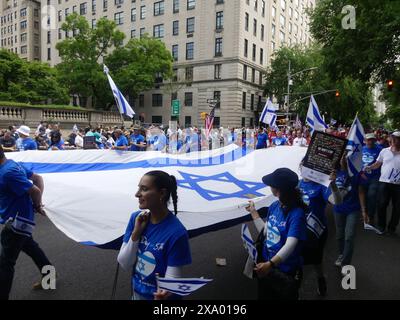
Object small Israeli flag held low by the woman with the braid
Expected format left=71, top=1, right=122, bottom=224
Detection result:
left=157, top=278, right=212, bottom=296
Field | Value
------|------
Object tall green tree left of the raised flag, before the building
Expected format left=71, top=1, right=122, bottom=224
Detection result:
left=56, top=13, right=125, bottom=107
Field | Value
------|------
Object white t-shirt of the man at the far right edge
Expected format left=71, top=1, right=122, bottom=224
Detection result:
left=376, top=147, right=400, bottom=185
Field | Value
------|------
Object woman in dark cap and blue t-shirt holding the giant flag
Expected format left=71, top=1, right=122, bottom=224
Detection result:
left=246, top=168, right=306, bottom=300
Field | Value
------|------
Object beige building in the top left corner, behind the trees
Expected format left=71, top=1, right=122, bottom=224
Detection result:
left=0, top=0, right=41, bottom=61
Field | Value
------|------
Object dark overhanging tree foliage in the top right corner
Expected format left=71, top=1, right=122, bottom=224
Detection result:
left=310, top=0, right=400, bottom=82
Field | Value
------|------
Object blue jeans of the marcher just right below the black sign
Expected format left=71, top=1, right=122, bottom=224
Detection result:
left=334, top=211, right=360, bottom=266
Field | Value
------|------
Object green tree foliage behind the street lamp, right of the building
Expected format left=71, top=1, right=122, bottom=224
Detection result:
left=264, top=46, right=374, bottom=123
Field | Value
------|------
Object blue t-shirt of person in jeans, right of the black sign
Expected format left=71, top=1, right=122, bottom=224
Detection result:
left=333, top=170, right=360, bottom=214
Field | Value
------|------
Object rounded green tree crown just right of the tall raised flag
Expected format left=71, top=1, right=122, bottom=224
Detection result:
left=104, top=36, right=173, bottom=98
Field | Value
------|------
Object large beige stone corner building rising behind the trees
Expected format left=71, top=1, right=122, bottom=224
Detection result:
left=0, top=0, right=315, bottom=127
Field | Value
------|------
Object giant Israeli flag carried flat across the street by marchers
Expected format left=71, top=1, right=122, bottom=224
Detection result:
left=7, top=144, right=306, bottom=249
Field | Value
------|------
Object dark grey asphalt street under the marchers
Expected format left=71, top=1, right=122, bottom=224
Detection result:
left=5, top=205, right=400, bottom=300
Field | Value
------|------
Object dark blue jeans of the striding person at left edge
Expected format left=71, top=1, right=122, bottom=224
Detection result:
left=0, top=225, right=51, bottom=300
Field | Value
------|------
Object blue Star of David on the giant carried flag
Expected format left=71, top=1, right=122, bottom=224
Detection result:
left=177, top=171, right=265, bottom=201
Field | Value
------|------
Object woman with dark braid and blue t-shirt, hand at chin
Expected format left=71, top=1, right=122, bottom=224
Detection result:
left=118, top=171, right=192, bottom=300
